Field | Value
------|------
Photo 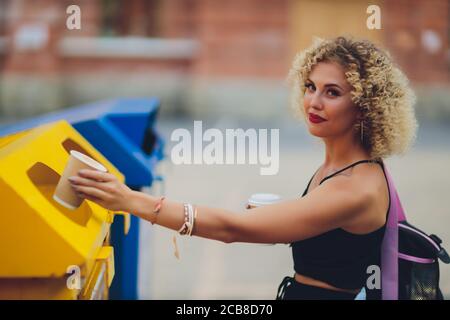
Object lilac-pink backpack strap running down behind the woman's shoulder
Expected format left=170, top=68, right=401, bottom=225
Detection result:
left=381, top=163, right=406, bottom=300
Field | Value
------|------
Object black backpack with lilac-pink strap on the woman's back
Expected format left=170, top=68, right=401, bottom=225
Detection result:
left=381, top=163, right=450, bottom=300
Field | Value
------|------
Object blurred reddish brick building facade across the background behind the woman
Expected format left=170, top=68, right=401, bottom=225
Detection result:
left=0, top=0, right=450, bottom=118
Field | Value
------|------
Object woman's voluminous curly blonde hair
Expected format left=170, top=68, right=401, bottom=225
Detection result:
left=288, top=37, right=417, bottom=158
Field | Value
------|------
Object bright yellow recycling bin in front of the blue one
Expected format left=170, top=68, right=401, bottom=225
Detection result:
left=0, top=121, right=129, bottom=299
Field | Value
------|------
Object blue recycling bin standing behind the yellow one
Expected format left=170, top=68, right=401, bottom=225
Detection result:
left=0, top=98, right=164, bottom=299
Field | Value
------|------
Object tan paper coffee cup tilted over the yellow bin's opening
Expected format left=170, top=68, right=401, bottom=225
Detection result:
left=53, top=150, right=108, bottom=210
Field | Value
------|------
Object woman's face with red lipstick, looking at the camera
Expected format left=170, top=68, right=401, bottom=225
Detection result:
left=303, top=62, right=357, bottom=138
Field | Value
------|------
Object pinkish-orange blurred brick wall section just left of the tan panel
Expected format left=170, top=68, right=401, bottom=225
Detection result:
left=195, top=0, right=289, bottom=78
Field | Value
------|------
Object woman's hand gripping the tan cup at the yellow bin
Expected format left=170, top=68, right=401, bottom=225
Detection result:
left=69, top=169, right=134, bottom=212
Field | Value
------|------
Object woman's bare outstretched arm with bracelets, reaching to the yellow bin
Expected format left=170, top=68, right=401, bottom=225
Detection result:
left=71, top=170, right=375, bottom=243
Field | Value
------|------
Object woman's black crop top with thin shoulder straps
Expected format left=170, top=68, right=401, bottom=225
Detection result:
left=291, top=160, right=391, bottom=289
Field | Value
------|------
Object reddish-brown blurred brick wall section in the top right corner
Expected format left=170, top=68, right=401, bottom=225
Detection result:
left=382, top=0, right=450, bottom=83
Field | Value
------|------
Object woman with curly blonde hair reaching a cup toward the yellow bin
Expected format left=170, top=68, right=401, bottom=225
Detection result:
left=70, top=37, right=416, bottom=299
